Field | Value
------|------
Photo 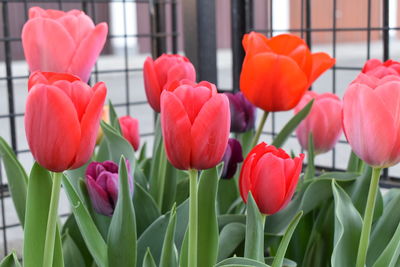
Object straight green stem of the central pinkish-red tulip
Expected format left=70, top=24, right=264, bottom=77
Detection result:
left=188, top=169, right=197, bottom=267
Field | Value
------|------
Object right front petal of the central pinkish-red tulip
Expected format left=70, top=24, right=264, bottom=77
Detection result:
left=191, top=94, right=231, bottom=170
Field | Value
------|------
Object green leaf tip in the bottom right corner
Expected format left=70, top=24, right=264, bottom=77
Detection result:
left=372, top=221, right=400, bottom=267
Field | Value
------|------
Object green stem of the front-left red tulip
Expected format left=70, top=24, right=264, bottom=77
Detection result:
left=43, top=172, right=63, bottom=267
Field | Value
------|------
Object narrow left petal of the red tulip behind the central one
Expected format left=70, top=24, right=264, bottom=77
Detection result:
left=143, top=57, right=161, bottom=112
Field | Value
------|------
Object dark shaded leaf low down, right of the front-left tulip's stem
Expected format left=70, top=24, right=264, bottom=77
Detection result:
left=61, top=214, right=93, bottom=266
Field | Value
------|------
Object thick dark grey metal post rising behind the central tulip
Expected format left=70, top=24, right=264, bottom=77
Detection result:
left=182, top=0, right=217, bottom=84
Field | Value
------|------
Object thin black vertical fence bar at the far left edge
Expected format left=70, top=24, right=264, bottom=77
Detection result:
left=2, top=0, right=17, bottom=154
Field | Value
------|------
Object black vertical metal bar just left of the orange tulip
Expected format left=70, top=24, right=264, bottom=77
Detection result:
left=231, top=0, right=246, bottom=91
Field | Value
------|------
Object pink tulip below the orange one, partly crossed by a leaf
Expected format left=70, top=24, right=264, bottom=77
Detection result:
left=294, top=91, right=342, bottom=154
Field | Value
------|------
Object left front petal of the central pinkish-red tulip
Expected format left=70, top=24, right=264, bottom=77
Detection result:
left=161, top=91, right=192, bottom=170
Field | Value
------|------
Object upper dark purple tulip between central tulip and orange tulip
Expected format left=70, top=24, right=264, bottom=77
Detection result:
left=225, top=92, right=256, bottom=133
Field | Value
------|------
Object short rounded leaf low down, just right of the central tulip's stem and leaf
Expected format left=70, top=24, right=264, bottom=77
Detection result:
left=218, top=222, right=246, bottom=261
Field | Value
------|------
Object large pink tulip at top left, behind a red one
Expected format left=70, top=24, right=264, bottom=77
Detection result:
left=22, top=7, right=108, bottom=82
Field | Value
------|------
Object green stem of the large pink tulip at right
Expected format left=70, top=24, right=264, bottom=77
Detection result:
left=356, top=168, right=381, bottom=267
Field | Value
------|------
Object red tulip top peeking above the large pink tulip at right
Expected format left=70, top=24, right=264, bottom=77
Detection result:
left=362, top=59, right=400, bottom=78
